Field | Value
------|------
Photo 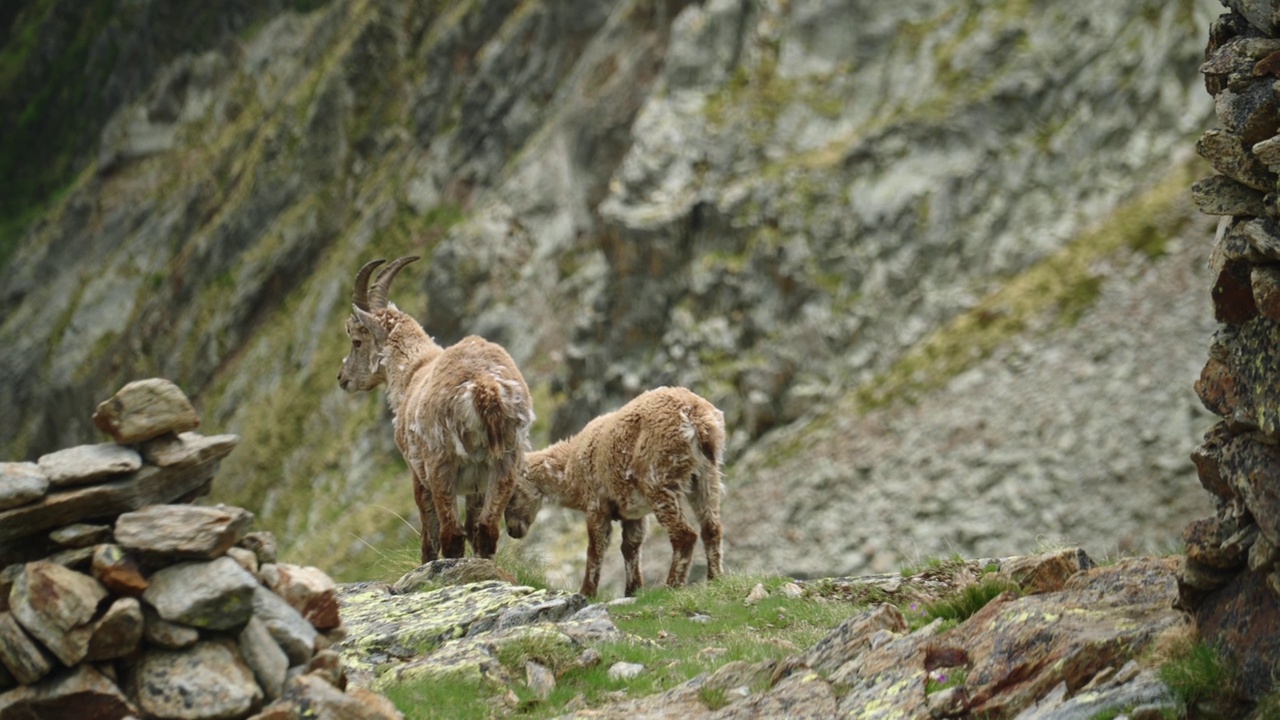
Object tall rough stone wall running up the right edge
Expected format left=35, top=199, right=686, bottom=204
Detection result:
left=1179, top=0, right=1280, bottom=700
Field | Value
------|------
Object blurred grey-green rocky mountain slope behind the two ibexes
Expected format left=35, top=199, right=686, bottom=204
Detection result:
left=0, top=0, right=1220, bottom=586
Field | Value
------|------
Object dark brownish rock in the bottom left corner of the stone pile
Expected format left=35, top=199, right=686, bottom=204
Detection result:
left=0, top=665, right=138, bottom=719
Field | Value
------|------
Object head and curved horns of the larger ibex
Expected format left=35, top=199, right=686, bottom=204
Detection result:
left=338, top=255, right=417, bottom=392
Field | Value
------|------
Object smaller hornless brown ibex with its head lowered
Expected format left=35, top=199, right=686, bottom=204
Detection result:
left=506, top=387, right=724, bottom=596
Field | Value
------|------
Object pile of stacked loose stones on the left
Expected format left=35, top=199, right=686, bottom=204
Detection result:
left=0, top=379, right=402, bottom=720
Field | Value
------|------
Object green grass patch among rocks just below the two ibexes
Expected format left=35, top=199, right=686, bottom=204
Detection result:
left=376, top=568, right=864, bottom=717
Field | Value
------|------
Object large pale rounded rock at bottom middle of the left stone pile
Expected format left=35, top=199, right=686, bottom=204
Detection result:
left=129, top=641, right=264, bottom=720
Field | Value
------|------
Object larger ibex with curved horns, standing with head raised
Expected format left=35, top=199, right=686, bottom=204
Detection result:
left=338, top=256, right=534, bottom=562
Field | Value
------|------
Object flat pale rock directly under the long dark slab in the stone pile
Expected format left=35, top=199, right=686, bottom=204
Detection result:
left=115, top=505, right=253, bottom=559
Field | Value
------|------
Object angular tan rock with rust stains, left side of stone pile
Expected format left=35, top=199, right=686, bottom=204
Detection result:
left=9, top=562, right=108, bottom=667
